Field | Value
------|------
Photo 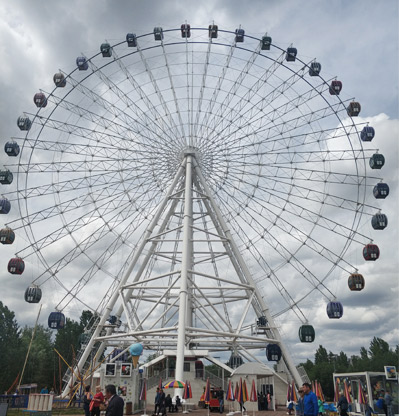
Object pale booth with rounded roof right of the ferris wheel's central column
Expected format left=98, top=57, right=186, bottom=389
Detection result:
left=230, top=363, right=288, bottom=412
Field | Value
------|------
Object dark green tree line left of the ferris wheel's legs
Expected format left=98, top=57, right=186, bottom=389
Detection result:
left=0, top=301, right=93, bottom=394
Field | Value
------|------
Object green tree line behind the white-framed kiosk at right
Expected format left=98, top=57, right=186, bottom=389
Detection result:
left=300, top=337, right=399, bottom=401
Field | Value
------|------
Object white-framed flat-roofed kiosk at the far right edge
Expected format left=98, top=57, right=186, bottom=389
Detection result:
left=333, top=367, right=399, bottom=415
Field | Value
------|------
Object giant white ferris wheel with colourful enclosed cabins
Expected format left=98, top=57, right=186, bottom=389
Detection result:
left=0, top=23, right=389, bottom=386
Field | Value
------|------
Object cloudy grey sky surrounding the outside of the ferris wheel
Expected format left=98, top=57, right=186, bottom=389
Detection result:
left=0, top=0, right=399, bottom=364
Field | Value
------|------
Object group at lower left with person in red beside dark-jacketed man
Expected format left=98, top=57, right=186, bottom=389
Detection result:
left=83, top=384, right=125, bottom=416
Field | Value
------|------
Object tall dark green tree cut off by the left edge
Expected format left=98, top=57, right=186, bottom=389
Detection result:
left=0, top=301, right=21, bottom=392
